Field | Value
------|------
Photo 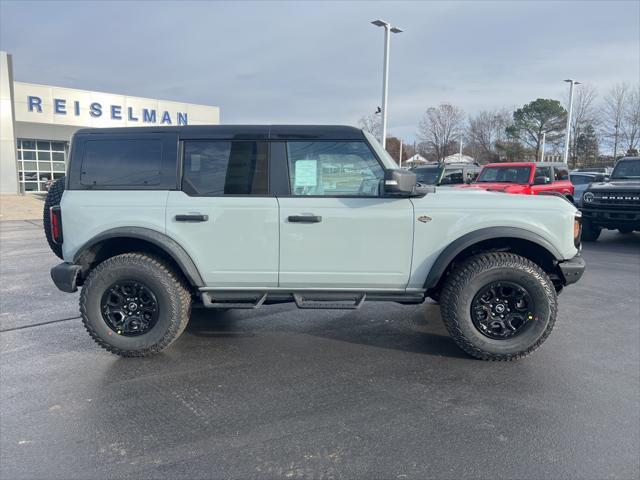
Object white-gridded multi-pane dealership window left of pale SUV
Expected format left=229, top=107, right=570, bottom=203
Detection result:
left=16, top=138, right=69, bottom=192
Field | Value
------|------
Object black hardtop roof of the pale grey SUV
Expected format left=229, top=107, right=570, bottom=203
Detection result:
left=76, top=125, right=364, bottom=140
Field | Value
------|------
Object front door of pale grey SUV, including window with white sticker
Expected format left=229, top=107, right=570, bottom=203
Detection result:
left=278, top=141, right=414, bottom=290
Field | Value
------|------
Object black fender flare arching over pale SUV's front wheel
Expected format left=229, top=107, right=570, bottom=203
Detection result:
left=424, top=227, right=563, bottom=290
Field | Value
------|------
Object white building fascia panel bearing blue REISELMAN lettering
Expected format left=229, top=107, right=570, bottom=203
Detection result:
left=13, top=82, right=220, bottom=128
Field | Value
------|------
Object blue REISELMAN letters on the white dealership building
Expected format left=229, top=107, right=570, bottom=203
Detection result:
left=27, top=95, right=188, bottom=125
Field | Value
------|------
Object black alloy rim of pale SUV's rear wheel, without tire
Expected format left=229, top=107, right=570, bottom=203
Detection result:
left=100, top=281, right=159, bottom=337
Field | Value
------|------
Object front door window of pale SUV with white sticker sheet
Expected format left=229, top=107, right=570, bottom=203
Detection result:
left=287, top=142, right=384, bottom=197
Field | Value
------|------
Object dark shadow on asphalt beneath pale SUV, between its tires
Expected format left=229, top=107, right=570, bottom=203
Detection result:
left=182, top=302, right=470, bottom=359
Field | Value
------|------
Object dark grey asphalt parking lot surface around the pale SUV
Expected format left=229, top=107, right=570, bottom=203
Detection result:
left=0, top=221, right=640, bottom=479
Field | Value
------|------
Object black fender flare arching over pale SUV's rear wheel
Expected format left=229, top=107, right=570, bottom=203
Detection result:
left=73, top=227, right=205, bottom=287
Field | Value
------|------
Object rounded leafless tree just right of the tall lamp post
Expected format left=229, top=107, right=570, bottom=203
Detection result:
left=418, top=103, right=464, bottom=161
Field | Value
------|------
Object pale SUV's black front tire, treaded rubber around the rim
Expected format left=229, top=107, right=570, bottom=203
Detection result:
left=440, top=252, right=558, bottom=361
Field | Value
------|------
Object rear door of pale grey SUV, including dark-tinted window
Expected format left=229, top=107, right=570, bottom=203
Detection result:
left=166, top=139, right=279, bottom=287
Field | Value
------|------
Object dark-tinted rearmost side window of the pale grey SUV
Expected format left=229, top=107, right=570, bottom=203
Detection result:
left=80, top=139, right=162, bottom=187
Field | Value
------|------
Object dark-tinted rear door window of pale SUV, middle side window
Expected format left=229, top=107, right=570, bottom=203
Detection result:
left=182, top=140, right=269, bottom=196
